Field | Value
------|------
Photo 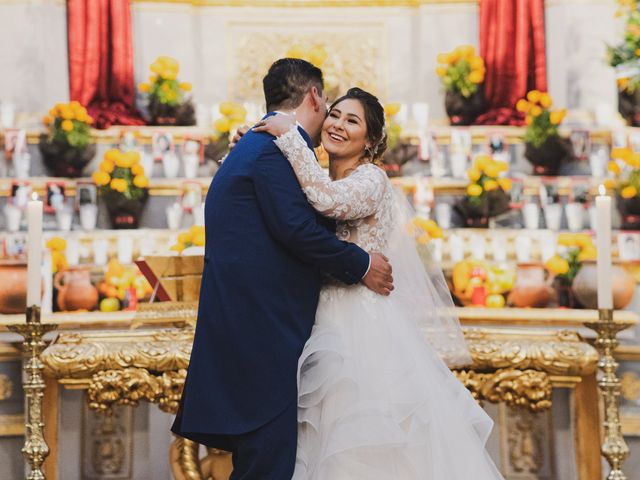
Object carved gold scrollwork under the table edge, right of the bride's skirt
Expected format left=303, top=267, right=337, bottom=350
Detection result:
left=454, top=368, right=551, bottom=412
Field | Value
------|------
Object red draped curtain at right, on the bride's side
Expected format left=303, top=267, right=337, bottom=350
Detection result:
left=475, top=0, right=547, bottom=125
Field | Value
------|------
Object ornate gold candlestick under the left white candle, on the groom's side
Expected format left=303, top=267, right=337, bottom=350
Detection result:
left=9, top=305, right=56, bottom=480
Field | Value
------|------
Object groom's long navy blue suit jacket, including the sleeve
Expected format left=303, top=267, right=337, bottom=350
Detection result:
left=173, top=121, right=369, bottom=437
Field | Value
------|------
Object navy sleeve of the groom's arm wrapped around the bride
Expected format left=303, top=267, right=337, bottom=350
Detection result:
left=253, top=144, right=369, bottom=284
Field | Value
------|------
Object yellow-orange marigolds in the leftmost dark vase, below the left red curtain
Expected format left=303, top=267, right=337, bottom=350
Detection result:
left=42, top=101, right=93, bottom=148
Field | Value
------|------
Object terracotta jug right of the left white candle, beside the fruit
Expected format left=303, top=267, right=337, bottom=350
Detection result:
left=53, top=268, right=98, bottom=311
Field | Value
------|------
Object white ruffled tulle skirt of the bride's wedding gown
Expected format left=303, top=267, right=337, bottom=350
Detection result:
left=293, top=286, right=503, bottom=480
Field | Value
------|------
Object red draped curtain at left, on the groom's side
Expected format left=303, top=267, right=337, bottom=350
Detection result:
left=67, top=0, right=144, bottom=128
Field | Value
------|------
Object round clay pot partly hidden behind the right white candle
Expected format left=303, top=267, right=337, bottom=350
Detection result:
left=573, top=262, right=636, bottom=310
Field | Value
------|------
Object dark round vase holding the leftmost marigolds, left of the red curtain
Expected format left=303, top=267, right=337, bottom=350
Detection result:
left=38, top=134, right=96, bottom=178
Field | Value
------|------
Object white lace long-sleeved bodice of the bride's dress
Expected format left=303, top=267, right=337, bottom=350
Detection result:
left=275, top=127, right=394, bottom=252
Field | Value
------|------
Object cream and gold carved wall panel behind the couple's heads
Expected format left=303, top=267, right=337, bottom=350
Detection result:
left=227, top=22, right=388, bottom=104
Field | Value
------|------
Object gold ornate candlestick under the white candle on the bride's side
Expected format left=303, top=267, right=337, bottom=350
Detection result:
left=586, top=309, right=630, bottom=480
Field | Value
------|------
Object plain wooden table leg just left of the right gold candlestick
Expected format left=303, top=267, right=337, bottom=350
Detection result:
left=573, top=373, right=602, bottom=480
